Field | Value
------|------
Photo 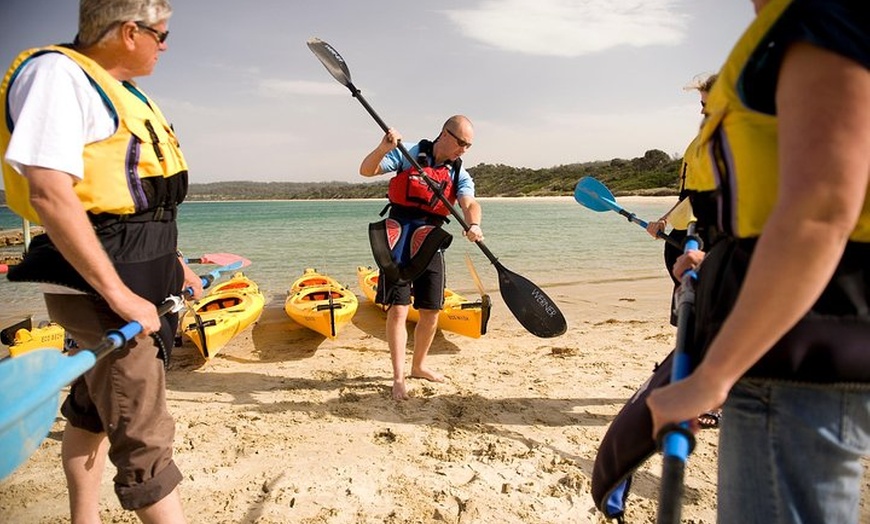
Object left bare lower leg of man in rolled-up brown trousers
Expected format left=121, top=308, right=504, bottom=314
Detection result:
left=61, top=424, right=109, bottom=524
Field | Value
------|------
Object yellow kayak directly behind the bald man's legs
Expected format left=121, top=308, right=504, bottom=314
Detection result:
left=356, top=266, right=492, bottom=338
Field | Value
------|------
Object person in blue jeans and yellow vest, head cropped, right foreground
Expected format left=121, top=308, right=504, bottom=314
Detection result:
left=647, top=0, right=870, bottom=523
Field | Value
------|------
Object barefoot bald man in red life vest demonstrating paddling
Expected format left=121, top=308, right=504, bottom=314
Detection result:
left=359, top=115, right=483, bottom=400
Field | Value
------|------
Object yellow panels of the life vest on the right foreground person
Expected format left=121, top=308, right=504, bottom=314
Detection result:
left=687, top=0, right=870, bottom=242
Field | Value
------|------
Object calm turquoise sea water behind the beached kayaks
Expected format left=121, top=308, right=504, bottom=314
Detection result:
left=0, top=197, right=676, bottom=327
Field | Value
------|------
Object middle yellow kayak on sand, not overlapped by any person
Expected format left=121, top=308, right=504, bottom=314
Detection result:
left=284, top=268, right=359, bottom=339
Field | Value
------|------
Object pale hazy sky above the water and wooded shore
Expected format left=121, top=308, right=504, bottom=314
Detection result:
left=0, top=0, right=754, bottom=183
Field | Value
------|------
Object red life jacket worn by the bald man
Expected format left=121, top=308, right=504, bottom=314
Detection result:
left=387, top=140, right=462, bottom=216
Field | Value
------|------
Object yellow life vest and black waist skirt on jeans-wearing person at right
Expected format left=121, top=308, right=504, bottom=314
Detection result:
left=687, top=0, right=870, bottom=383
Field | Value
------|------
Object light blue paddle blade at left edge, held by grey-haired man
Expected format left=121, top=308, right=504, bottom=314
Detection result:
left=0, top=348, right=96, bottom=480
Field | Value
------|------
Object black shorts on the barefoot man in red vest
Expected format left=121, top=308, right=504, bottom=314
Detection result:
left=375, top=251, right=447, bottom=310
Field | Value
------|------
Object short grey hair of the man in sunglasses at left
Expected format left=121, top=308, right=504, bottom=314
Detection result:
left=76, top=0, right=172, bottom=47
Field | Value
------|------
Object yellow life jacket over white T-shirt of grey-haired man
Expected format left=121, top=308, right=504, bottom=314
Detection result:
left=0, top=46, right=187, bottom=223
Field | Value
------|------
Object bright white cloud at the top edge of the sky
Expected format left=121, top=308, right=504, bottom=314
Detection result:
left=445, top=0, right=687, bottom=57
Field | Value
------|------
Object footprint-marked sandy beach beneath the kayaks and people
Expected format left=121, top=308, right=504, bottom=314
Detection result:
left=0, top=274, right=867, bottom=524
